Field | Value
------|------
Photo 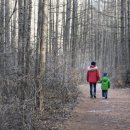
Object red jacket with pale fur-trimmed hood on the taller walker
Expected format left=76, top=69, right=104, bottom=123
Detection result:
left=86, top=65, right=100, bottom=83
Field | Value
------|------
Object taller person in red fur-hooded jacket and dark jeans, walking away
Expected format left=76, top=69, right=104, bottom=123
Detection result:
left=86, top=61, right=100, bottom=98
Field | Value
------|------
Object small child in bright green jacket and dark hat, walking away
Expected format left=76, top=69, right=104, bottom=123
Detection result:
left=99, top=72, right=110, bottom=99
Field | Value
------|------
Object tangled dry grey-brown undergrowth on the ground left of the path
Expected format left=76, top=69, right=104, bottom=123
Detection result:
left=0, top=70, right=79, bottom=130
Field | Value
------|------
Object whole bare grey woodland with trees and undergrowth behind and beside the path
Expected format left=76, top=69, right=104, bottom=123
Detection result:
left=0, top=0, right=130, bottom=130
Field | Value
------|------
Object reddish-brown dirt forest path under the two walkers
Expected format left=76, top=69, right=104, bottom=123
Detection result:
left=64, top=85, right=130, bottom=130
